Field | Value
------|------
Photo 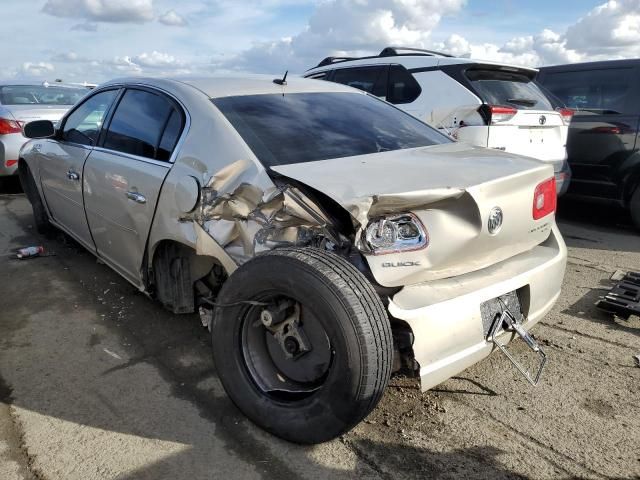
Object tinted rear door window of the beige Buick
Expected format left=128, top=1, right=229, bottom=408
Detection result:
left=103, top=89, right=183, bottom=161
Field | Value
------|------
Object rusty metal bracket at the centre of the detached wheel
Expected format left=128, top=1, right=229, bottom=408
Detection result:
left=260, top=300, right=311, bottom=359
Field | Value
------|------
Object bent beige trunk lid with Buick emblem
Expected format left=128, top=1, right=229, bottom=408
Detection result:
left=272, top=143, right=553, bottom=286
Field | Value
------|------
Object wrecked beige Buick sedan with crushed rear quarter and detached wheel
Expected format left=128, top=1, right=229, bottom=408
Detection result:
left=19, top=77, right=566, bottom=443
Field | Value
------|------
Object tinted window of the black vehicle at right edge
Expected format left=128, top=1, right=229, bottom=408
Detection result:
left=542, top=68, right=634, bottom=114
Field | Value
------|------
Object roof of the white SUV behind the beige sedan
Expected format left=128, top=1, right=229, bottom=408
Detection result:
left=304, top=54, right=537, bottom=75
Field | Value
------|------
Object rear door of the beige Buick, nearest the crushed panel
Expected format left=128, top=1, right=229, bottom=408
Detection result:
left=84, top=88, right=185, bottom=285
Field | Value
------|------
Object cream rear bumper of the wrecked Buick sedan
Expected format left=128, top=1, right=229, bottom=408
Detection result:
left=388, top=224, right=567, bottom=391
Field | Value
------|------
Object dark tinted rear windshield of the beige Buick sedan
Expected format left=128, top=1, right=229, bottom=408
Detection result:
left=212, top=93, right=450, bottom=166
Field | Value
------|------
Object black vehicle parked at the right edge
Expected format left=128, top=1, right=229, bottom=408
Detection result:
left=537, top=60, right=640, bottom=228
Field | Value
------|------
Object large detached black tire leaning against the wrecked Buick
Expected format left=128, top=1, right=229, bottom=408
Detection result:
left=212, top=248, right=393, bottom=444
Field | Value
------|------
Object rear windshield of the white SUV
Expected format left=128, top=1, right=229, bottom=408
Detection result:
left=467, top=70, right=553, bottom=110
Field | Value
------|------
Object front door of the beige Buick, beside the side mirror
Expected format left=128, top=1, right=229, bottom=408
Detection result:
left=38, top=88, right=118, bottom=250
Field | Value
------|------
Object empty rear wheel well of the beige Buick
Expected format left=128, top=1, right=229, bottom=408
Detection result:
left=147, top=240, right=224, bottom=313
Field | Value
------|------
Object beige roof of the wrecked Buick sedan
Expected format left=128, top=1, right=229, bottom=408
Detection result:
left=99, top=75, right=362, bottom=98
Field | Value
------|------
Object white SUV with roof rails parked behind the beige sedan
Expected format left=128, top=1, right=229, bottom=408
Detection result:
left=304, top=47, right=573, bottom=195
